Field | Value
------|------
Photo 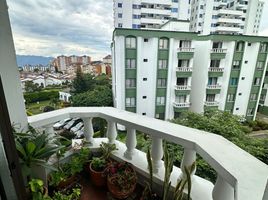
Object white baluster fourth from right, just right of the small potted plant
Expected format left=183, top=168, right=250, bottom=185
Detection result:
left=124, top=128, right=137, bottom=160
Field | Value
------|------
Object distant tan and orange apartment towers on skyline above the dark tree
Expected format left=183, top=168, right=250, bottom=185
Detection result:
left=52, top=55, right=91, bottom=71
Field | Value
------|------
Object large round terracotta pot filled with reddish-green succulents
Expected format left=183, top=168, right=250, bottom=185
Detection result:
left=107, top=162, right=137, bottom=199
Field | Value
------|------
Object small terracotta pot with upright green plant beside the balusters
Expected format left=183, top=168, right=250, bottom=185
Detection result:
left=88, top=142, right=116, bottom=187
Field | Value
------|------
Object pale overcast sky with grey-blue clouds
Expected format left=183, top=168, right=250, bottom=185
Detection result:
left=7, top=0, right=268, bottom=60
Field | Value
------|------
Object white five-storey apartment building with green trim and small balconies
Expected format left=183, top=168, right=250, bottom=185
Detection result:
left=112, top=29, right=268, bottom=119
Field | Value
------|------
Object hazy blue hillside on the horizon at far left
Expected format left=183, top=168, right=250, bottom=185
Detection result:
left=17, top=55, right=54, bottom=66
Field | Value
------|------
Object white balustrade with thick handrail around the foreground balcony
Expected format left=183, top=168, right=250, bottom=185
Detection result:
left=25, top=108, right=268, bottom=200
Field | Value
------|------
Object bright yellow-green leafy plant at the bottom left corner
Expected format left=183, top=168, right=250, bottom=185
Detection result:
left=28, top=179, right=51, bottom=200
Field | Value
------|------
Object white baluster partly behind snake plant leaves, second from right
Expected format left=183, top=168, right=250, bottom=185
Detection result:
left=180, top=148, right=196, bottom=179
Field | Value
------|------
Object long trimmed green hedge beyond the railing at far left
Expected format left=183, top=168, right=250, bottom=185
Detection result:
left=24, top=91, right=59, bottom=103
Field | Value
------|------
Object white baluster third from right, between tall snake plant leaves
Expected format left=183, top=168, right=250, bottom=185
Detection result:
left=152, top=137, right=163, bottom=173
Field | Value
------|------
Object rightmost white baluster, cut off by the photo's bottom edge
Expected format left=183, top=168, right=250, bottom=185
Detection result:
left=212, top=174, right=234, bottom=200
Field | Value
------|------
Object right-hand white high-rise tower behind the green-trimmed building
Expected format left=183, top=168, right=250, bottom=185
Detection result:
left=190, top=0, right=264, bottom=35
